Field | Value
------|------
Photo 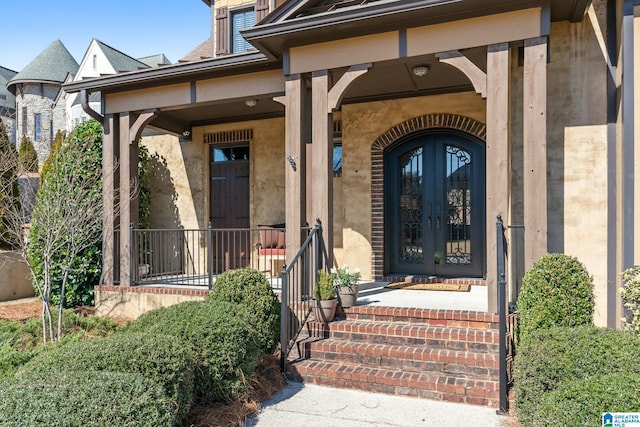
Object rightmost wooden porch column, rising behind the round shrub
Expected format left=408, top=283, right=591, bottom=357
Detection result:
left=523, top=37, right=547, bottom=270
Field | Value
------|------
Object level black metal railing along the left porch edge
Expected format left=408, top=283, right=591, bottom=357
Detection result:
left=113, top=226, right=309, bottom=288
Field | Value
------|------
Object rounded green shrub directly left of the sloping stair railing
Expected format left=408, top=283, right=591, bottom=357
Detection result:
left=207, top=268, right=280, bottom=353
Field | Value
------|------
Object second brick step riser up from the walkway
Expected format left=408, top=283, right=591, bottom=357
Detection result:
left=307, top=346, right=500, bottom=380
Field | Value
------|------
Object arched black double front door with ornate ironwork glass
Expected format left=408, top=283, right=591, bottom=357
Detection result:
left=385, top=131, right=485, bottom=277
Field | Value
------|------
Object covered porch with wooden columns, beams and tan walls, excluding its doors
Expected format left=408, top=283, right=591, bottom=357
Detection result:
left=65, top=1, right=588, bottom=318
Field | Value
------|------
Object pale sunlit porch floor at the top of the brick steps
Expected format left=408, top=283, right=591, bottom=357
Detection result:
left=134, top=277, right=488, bottom=312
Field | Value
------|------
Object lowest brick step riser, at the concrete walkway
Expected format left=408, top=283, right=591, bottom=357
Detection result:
left=288, top=369, right=499, bottom=408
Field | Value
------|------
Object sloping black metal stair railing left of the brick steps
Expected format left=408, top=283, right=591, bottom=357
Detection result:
left=280, top=220, right=329, bottom=372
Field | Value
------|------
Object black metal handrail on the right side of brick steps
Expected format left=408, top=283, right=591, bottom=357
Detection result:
left=496, top=216, right=524, bottom=414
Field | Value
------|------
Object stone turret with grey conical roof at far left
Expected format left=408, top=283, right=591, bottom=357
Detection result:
left=7, top=40, right=78, bottom=165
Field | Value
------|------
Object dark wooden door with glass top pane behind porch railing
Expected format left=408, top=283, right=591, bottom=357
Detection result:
left=209, top=146, right=251, bottom=273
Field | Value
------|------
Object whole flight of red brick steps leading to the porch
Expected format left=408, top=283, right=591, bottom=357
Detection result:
left=288, top=306, right=499, bottom=407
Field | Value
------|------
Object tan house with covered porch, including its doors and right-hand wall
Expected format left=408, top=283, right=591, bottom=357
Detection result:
left=65, top=0, right=640, bottom=327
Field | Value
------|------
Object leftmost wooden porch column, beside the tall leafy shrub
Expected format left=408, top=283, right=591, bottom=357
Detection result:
left=101, top=114, right=119, bottom=286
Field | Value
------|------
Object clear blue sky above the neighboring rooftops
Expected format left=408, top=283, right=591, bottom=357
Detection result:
left=0, top=0, right=211, bottom=71
